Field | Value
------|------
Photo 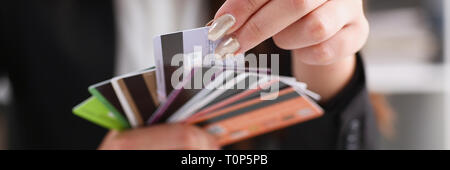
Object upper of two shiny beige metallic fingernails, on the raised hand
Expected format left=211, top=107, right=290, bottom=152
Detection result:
left=208, top=14, right=236, bottom=41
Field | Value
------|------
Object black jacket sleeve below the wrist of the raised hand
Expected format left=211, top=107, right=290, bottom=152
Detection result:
left=322, top=54, right=378, bottom=149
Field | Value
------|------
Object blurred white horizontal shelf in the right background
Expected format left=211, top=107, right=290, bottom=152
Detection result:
left=366, top=64, right=445, bottom=94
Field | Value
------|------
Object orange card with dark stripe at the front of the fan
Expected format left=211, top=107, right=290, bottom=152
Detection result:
left=187, top=87, right=324, bottom=146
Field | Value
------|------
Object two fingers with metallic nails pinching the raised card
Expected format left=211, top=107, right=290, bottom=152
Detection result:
left=209, top=0, right=327, bottom=56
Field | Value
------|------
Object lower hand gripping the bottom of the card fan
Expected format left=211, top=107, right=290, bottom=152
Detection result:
left=99, top=124, right=220, bottom=150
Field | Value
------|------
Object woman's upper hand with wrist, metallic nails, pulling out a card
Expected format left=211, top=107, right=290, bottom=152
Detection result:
left=208, top=0, right=369, bottom=101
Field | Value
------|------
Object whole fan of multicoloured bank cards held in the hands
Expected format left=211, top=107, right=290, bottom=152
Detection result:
left=73, top=27, right=324, bottom=145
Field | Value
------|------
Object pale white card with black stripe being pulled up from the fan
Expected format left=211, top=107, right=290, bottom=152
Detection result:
left=153, top=27, right=221, bottom=102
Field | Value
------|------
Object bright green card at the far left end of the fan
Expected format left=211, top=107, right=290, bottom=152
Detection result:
left=72, top=96, right=128, bottom=130
